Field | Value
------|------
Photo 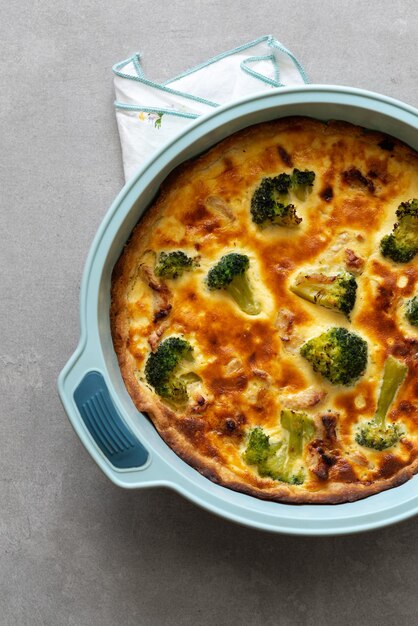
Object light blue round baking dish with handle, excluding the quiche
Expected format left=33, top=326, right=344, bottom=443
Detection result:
left=58, top=85, right=418, bottom=535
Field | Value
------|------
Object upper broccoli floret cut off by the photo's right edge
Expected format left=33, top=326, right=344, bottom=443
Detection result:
left=380, top=199, right=418, bottom=263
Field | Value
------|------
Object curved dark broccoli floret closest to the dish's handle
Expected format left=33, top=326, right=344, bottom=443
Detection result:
left=145, top=337, right=193, bottom=404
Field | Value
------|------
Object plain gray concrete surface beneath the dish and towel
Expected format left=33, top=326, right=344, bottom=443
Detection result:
left=0, top=0, right=418, bottom=626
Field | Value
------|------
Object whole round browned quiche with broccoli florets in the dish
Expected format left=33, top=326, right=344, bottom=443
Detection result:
left=110, top=117, right=418, bottom=504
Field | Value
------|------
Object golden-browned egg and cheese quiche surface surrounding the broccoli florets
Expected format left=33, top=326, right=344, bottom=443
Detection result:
left=111, top=117, right=418, bottom=503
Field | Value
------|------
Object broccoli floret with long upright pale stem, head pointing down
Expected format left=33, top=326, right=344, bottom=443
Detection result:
left=356, top=356, right=408, bottom=450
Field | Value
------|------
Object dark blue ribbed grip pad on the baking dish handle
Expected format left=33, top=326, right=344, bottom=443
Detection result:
left=74, top=371, right=149, bottom=469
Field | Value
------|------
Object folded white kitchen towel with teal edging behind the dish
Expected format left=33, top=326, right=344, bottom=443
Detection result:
left=113, top=35, right=308, bottom=180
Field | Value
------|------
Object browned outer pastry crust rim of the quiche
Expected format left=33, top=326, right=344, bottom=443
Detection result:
left=110, top=118, right=418, bottom=503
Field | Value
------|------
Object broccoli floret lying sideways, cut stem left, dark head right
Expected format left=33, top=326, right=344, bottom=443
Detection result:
left=290, top=270, right=357, bottom=317
